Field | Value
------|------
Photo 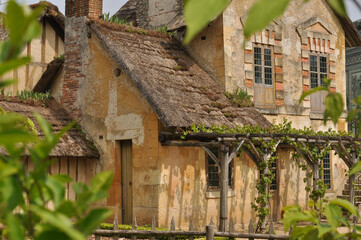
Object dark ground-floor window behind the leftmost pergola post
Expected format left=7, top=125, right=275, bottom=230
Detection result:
left=206, top=147, right=234, bottom=189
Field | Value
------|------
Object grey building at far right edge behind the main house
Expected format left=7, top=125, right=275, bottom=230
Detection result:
left=346, top=20, right=361, bottom=131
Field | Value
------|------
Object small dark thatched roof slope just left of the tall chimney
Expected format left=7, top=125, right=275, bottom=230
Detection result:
left=33, top=58, right=64, bottom=93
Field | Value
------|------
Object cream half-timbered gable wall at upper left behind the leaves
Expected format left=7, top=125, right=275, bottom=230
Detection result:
left=2, top=21, right=64, bottom=96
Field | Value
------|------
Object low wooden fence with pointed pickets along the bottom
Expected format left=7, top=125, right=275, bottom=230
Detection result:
left=94, top=215, right=289, bottom=240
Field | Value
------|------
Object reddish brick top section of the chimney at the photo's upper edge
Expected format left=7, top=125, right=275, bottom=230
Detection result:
left=65, top=0, right=103, bottom=19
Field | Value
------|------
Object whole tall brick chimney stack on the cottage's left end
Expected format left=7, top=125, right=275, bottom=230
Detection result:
left=60, top=0, right=103, bottom=121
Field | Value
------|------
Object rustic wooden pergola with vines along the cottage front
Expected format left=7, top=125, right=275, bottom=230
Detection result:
left=159, top=132, right=361, bottom=231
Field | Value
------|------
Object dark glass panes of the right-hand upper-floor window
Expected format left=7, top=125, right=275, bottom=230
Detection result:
left=310, top=55, right=328, bottom=88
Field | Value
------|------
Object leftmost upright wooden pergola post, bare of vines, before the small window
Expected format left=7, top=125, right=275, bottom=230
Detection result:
left=219, top=144, right=229, bottom=232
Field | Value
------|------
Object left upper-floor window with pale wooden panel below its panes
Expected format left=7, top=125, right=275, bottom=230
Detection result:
left=253, top=45, right=275, bottom=108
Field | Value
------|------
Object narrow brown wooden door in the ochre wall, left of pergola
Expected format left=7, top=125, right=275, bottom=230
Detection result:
left=120, top=140, right=133, bottom=224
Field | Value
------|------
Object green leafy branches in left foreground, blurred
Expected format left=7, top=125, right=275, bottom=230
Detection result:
left=0, top=0, right=113, bottom=240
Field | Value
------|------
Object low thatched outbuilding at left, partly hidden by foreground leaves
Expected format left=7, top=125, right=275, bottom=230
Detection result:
left=0, top=96, right=99, bottom=200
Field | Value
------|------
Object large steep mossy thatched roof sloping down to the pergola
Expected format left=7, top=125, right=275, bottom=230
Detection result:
left=90, top=21, right=270, bottom=128
